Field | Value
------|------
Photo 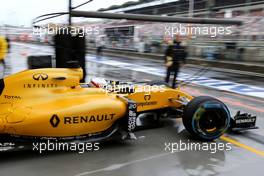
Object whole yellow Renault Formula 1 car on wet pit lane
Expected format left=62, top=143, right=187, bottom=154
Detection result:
left=0, top=68, right=256, bottom=151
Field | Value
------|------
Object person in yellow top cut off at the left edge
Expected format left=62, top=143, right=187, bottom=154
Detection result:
left=0, top=36, right=8, bottom=78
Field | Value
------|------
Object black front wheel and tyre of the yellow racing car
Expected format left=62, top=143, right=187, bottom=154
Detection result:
left=182, top=96, right=231, bottom=141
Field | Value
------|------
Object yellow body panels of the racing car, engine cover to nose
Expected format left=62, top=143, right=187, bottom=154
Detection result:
left=0, top=68, right=192, bottom=137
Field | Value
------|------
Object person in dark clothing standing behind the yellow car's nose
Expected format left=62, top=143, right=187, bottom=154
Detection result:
left=165, top=36, right=187, bottom=88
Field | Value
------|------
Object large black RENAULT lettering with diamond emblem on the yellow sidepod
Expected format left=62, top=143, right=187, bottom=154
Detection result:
left=50, top=114, right=116, bottom=128
